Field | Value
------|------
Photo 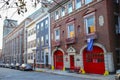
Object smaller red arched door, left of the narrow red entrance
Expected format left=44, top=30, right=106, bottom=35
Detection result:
left=54, top=50, right=63, bottom=70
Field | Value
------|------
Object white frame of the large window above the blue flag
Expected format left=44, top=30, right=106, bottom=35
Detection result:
left=84, top=12, right=96, bottom=34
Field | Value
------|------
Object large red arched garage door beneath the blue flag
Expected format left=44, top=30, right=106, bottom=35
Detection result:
left=83, top=46, right=105, bottom=74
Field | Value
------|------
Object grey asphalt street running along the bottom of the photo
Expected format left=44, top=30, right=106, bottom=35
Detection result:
left=0, top=68, right=95, bottom=80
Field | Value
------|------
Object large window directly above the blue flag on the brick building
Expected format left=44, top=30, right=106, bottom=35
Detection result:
left=85, top=14, right=95, bottom=34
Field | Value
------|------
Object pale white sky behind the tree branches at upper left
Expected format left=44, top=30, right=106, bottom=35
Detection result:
left=0, top=0, right=40, bottom=49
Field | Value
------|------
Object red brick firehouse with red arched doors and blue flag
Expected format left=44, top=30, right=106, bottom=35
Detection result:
left=49, top=0, right=120, bottom=74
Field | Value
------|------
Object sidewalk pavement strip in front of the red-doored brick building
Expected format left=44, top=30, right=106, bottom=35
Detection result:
left=35, top=68, right=115, bottom=80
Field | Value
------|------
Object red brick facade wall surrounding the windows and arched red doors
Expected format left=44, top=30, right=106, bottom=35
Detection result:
left=51, top=0, right=116, bottom=72
